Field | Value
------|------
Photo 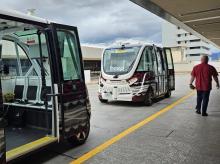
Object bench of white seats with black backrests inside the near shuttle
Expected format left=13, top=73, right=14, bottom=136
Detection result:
left=4, top=76, right=52, bottom=129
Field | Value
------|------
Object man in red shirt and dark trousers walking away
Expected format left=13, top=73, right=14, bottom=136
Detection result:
left=189, top=56, right=219, bottom=116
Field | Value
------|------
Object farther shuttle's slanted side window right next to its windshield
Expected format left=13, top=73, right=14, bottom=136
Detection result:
left=137, top=47, right=153, bottom=72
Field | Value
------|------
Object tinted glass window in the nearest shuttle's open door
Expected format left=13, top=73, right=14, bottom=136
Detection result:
left=57, top=31, right=82, bottom=80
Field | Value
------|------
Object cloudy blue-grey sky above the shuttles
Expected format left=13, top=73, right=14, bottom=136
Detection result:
left=1, top=0, right=163, bottom=44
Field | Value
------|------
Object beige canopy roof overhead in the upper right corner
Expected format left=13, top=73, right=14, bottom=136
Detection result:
left=131, top=0, right=220, bottom=47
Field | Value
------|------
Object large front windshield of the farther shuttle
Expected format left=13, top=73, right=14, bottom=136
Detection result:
left=103, top=46, right=141, bottom=75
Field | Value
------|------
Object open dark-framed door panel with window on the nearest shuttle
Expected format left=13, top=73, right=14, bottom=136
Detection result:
left=51, top=23, right=90, bottom=138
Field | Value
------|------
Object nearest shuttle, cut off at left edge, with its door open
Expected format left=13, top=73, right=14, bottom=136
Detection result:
left=0, top=10, right=90, bottom=164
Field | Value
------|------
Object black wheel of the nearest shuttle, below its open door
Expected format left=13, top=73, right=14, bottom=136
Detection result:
left=68, top=120, right=90, bottom=146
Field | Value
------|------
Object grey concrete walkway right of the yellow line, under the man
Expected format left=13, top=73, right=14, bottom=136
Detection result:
left=86, top=90, right=220, bottom=164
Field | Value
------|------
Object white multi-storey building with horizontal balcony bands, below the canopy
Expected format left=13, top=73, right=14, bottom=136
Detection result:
left=162, top=22, right=211, bottom=62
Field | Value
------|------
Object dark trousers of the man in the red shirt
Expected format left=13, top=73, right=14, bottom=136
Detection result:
left=196, top=90, right=210, bottom=113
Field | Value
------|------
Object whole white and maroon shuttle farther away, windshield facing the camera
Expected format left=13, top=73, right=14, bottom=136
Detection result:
left=98, top=44, right=175, bottom=105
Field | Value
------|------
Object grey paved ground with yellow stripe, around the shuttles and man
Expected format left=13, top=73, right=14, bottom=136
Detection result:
left=13, top=74, right=220, bottom=164
